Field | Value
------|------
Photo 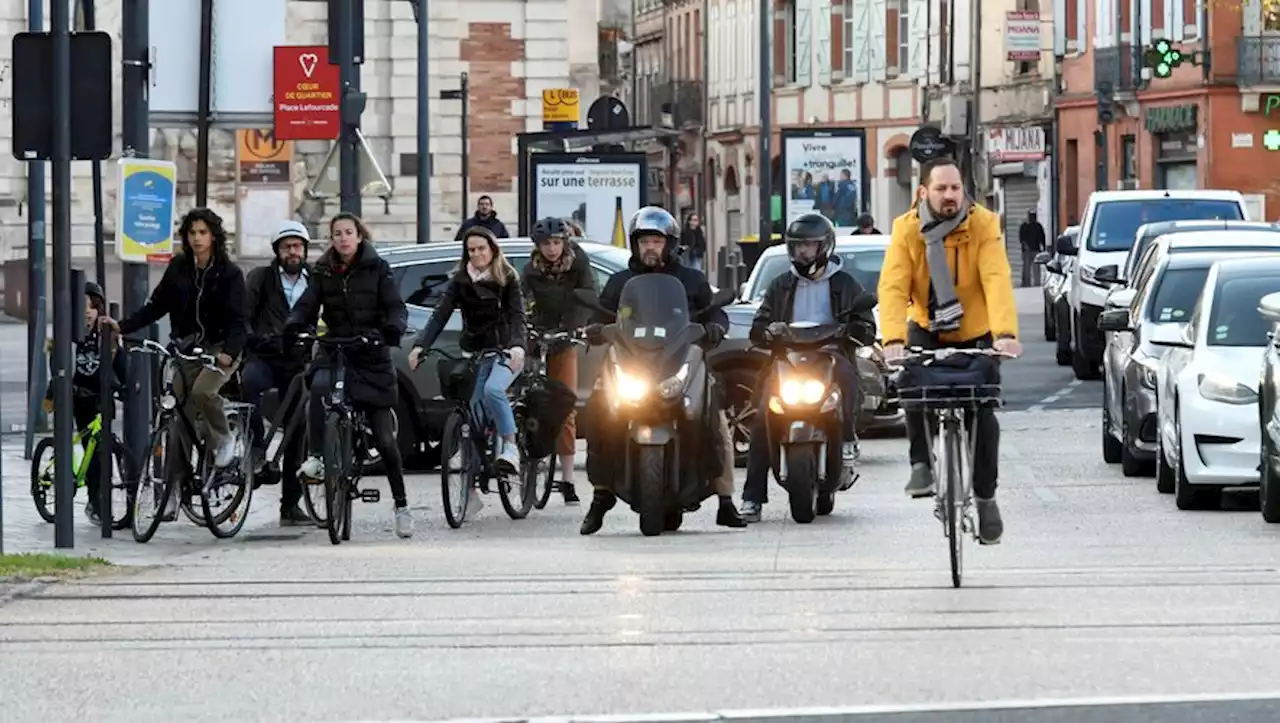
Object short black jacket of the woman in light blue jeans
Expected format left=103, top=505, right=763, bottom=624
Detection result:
left=413, top=264, right=525, bottom=352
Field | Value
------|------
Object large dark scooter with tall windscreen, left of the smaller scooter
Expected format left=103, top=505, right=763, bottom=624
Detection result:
left=576, top=274, right=733, bottom=536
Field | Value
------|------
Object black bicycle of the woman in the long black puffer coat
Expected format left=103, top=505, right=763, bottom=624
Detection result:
left=298, top=334, right=384, bottom=545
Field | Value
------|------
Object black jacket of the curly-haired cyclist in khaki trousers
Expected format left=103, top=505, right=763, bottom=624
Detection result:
left=120, top=253, right=248, bottom=357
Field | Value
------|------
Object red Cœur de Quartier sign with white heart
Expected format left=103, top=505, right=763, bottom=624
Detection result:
left=274, top=45, right=342, bottom=141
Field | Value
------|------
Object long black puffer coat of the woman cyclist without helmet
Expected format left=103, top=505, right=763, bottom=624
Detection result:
left=287, top=243, right=408, bottom=408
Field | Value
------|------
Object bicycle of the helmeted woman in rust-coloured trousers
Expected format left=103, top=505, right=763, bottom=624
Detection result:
left=503, top=329, right=586, bottom=506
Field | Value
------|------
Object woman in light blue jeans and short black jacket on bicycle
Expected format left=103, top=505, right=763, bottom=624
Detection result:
left=408, top=226, right=525, bottom=478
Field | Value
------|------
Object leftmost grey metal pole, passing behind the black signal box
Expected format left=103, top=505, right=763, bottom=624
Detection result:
left=23, top=0, right=49, bottom=459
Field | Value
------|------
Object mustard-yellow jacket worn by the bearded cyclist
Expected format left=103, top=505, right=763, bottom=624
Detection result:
left=877, top=203, right=1018, bottom=344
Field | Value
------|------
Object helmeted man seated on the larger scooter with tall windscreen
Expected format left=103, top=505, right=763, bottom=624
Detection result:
left=579, top=206, right=746, bottom=535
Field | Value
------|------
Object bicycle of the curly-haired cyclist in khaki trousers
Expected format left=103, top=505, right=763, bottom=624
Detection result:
left=125, top=339, right=253, bottom=543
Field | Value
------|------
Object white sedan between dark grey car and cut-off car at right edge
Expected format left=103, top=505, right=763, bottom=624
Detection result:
left=1151, top=257, right=1280, bottom=509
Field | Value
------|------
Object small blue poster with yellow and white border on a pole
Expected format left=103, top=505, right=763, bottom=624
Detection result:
left=115, top=159, right=178, bottom=264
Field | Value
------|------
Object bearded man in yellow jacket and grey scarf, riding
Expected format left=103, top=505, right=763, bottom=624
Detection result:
left=878, top=159, right=1021, bottom=545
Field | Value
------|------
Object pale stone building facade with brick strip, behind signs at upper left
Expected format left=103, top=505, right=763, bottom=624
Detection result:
left=0, top=0, right=602, bottom=258
